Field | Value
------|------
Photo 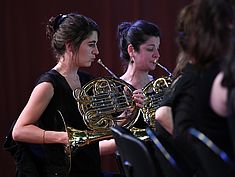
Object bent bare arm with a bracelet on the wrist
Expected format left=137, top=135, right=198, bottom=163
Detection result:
left=12, top=82, right=68, bottom=144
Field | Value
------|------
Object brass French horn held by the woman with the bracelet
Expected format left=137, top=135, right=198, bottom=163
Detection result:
left=63, top=61, right=140, bottom=148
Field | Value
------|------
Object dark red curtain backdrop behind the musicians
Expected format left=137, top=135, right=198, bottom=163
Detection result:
left=0, top=0, right=190, bottom=177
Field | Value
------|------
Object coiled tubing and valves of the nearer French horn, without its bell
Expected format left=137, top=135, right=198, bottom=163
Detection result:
left=74, top=77, right=139, bottom=131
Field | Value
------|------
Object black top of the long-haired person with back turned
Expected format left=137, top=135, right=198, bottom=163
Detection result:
left=173, top=61, right=232, bottom=157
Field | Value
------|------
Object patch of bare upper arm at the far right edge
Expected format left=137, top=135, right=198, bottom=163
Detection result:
left=210, top=72, right=227, bottom=117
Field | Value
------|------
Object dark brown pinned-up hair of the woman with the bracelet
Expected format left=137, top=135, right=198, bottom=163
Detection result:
left=46, top=13, right=99, bottom=58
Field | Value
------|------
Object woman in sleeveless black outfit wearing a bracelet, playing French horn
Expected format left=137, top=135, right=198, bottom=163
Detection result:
left=12, top=13, right=143, bottom=177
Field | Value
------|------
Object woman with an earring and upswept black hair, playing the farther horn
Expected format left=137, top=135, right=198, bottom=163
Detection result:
left=100, top=20, right=163, bottom=153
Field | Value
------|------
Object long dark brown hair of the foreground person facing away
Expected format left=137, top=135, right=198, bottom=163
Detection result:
left=187, top=0, right=234, bottom=66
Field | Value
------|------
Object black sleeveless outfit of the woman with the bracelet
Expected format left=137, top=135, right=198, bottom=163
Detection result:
left=38, top=70, right=101, bottom=177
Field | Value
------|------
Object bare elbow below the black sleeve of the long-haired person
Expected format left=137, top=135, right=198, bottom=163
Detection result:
left=155, top=106, right=173, bottom=134
